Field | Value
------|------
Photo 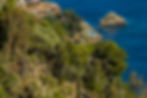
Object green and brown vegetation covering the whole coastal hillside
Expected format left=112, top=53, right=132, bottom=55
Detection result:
left=0, top=0, right=146, bottom=98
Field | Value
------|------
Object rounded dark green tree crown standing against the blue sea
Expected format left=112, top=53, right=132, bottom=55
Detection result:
left=93, top=42, right=127, bottom=78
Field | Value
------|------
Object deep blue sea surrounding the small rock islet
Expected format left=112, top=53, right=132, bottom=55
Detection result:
left=51, top=0, right=147, bottom=80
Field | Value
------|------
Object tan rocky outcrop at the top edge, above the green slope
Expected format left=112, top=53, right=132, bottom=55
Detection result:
left=16, top=0, right=61, bottom=17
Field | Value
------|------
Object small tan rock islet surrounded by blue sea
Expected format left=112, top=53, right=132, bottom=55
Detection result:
left=100, top=12, right=126, bottom=29
